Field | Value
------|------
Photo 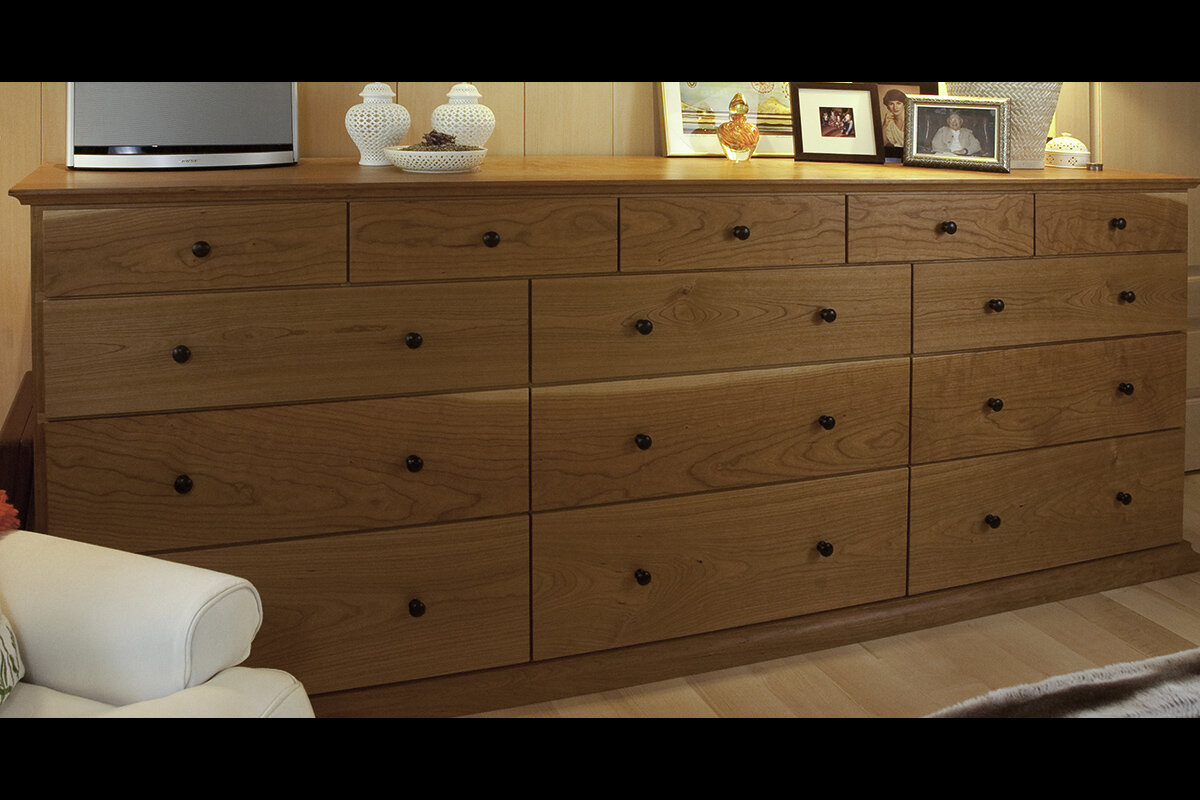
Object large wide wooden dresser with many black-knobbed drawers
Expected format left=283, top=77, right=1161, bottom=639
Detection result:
left=11, top=157, right=1200, bottom=716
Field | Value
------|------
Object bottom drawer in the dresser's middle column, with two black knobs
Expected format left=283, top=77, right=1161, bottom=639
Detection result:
left=533, top=469, right=907, bottom=658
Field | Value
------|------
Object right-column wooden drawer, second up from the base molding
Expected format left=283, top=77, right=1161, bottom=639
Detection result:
left=912, top=335, right=1186, bottom=464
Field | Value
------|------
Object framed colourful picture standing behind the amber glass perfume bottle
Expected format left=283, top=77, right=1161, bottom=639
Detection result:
left=659, top=82, right=792, bottom=158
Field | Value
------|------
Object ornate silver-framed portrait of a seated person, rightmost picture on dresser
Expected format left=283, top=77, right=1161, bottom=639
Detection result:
left=904, top=95, right=1009, bottom=173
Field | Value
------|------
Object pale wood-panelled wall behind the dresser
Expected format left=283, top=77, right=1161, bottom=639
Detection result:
left=7, top=80, right=1200, bottom=469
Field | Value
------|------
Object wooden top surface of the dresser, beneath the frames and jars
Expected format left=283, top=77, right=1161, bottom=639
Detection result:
left=8, top=156, right=1200, bottom=206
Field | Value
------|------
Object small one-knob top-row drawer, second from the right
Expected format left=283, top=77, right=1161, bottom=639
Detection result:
left=846, top=192, right=1033, bottom=263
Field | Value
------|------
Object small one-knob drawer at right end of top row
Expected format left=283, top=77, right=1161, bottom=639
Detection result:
left=1037, top=192, right=1188, bottom=255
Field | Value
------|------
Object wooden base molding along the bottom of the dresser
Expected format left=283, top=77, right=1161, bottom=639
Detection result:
left=311, top=542, right=1200, bottom=717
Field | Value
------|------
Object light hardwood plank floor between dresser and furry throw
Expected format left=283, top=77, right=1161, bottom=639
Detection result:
left=476, top=473, right=1200, bottom=717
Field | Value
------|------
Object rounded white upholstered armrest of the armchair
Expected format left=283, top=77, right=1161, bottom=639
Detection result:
left=0, top=530, right=263, bottom=705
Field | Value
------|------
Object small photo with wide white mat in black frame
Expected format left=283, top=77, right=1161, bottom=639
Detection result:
left=791, top=83, right=883, bottom=164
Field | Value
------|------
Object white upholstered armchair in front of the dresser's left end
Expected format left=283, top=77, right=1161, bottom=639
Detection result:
left=0, top=530, right=313, bottom=717
